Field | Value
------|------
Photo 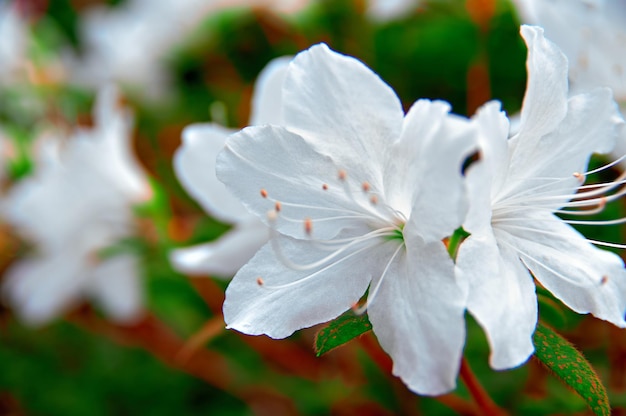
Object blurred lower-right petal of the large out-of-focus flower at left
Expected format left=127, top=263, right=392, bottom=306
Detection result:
left=86, top=255, right=143, bottom=323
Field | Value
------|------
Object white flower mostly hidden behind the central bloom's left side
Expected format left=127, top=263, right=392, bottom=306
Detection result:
left=170, top=57, right=292, bottom=277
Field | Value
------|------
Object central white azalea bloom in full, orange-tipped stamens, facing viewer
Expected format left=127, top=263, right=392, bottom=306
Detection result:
left=217, top=45, right=476, bottom=394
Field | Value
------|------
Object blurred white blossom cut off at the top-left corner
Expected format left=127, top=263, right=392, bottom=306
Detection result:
left=0, top=1, right=28, bottom=85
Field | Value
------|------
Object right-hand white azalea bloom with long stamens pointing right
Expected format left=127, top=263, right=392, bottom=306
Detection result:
left=457, top=26, right=626, bottom=369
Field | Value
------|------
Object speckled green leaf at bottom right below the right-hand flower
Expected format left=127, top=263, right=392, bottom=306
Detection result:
left=533, top=323, right=611, bottom=416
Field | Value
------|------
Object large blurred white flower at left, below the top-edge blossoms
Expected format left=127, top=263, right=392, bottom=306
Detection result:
left=3, top=87, right=150, bottom=324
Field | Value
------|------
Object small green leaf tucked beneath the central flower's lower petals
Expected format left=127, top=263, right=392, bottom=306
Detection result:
left=315, top=311, right=372, bottom=357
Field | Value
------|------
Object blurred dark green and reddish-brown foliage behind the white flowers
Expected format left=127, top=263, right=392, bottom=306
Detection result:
left=0, top=0, right=626, bottom=416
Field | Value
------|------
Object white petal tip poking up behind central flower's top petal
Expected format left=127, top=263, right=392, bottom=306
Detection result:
left=250, top=56, right=293, bottom=126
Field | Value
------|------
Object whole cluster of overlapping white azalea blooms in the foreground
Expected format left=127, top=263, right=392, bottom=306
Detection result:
left=172, top=26, right=626, bottom=395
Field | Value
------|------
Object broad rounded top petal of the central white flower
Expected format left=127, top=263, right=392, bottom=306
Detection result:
left=283, top=44, right=404, bottom=187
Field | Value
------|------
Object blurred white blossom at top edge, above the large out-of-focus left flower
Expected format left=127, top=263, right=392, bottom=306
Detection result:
left=71, top=0, right=218, bottom=96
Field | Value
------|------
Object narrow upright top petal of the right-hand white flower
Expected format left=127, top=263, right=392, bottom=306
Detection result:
left=510, top=26, right=568, bottom=146
